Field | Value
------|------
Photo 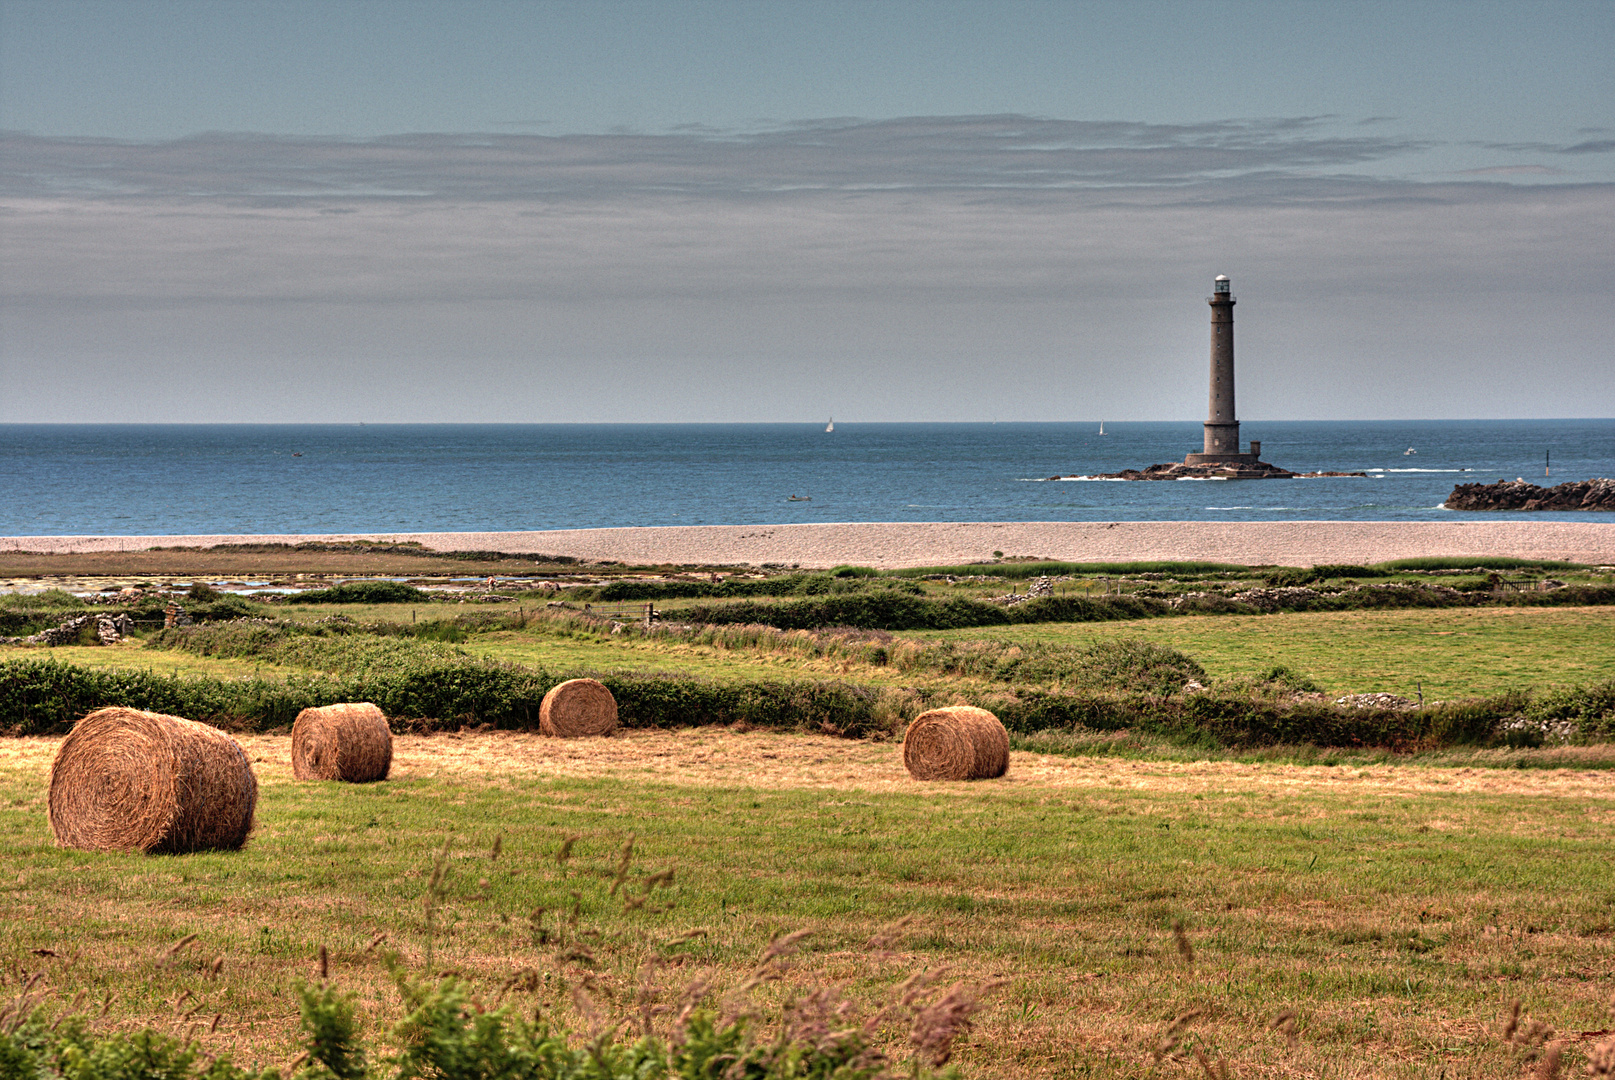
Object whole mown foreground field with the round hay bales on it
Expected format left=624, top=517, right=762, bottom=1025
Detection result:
left=0, top=730, right=1615, bottom=1080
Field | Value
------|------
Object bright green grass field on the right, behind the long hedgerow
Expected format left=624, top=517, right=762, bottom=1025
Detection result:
left=906, top=607, right=1615, bottom=699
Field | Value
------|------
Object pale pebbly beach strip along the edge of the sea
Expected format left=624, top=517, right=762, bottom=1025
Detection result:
left=0, top=520, right=1615, bottom=568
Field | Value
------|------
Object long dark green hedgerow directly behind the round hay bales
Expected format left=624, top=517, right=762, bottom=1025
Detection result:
left=0, top=648, right=1615, bottom=749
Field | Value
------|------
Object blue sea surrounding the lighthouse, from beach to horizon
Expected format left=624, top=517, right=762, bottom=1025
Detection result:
left=0, top=420, right=1615, bottom=536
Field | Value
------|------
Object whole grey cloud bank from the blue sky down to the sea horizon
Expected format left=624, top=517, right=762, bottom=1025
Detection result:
left=0, top=116, right=1615, bottom=421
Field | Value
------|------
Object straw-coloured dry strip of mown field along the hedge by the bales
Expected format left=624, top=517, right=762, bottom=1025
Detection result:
left=0, top=728, right=1615, bottom=799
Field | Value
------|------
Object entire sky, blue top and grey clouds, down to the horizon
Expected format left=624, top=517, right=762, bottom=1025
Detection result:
left=0, top=0, right=1615, bottom=425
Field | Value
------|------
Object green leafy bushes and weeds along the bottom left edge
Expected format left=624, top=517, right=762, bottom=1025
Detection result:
left=0, top=969, right=975, bottom=1080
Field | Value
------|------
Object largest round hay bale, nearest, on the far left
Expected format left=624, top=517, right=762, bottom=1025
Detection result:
left=48, top=709, right=258, bottom=854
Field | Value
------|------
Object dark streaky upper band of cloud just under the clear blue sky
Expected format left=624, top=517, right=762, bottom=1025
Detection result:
left=0, top=116, right=1428, bottom=200
